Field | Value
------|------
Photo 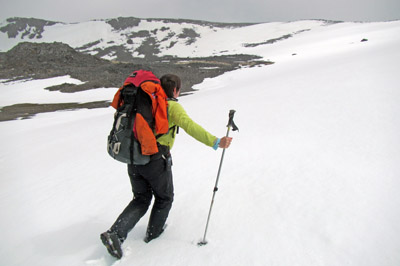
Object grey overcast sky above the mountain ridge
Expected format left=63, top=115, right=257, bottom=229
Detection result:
left=0, top=0, right=400, bottom=22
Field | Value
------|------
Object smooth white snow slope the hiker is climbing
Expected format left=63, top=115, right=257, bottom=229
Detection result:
left=0, top=19, right=400, bottom=266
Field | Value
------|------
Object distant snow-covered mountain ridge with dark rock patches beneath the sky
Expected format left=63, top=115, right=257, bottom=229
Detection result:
left=0, top=17, right=333, bottom=61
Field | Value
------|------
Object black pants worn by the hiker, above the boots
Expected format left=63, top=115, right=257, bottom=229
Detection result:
left=111, top=158, right=174, bottom=241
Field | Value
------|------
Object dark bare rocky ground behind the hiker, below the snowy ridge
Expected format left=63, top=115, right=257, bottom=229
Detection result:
left=0, top=42, right=271, bottom=121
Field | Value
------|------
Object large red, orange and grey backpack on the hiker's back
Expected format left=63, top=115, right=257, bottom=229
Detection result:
left=107, top=70, right=169, bottom=165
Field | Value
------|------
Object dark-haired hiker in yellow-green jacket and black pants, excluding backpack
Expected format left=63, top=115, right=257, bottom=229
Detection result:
left=101, top=74, right=232, bottom=258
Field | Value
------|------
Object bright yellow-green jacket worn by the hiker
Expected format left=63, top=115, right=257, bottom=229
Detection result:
left=157, top=100, right=218, bottom=149
